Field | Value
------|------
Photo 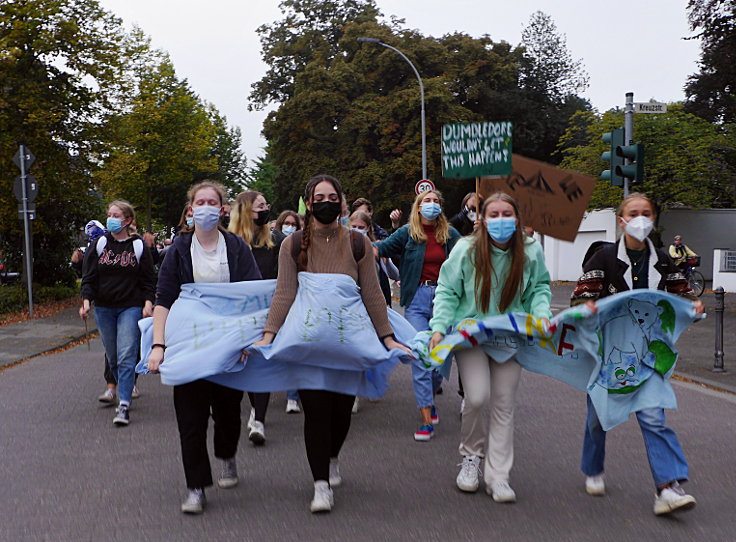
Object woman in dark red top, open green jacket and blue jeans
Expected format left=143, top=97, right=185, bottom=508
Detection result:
left=376, top=191, right=460, bottom=441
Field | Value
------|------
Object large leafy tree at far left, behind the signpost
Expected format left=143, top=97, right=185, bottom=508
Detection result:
left=0, top=0, right=129, bottom=283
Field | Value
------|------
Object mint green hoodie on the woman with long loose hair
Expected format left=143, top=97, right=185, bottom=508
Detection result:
left=429, top=236, right=552, bottom=334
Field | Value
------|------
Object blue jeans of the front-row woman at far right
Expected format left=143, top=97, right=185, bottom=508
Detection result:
left=580, top=397, right=688, bottom=487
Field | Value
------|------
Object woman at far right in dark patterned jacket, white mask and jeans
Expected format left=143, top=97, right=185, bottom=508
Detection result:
left=571, top=193, right=703, bottom=515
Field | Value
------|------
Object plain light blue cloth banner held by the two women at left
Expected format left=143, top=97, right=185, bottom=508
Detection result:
left=137, top=273, right=416, bottom=398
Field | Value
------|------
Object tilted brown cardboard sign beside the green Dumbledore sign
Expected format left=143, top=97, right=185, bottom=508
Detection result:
left=478, top=154, right=596, bottom=241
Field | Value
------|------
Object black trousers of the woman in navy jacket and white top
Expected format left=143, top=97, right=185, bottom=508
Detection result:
left=174, top=380, right=243, bottom=489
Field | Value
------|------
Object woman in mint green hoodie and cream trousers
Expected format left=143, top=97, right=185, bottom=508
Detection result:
left=430, top=192, right=552, bottom=502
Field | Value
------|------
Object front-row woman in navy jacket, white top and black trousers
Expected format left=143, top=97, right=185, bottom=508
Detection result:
left=148, top=181, right=261, bottom=514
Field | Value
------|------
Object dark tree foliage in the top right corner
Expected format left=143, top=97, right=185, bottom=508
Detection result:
left=685, top=0, right=736, bottom=123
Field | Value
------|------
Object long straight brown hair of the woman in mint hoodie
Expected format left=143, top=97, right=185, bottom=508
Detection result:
left=473, top=192, right=526, bottom=313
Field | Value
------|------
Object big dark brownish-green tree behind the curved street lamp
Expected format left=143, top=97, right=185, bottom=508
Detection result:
left=250, top=0, right=588, bottom=220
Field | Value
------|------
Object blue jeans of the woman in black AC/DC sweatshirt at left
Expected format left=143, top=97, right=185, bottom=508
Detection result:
left=95, top=307, right=143, bottom=404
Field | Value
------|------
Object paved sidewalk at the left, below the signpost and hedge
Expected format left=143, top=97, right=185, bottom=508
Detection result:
left=0, top=305, right=97, bottom=369
